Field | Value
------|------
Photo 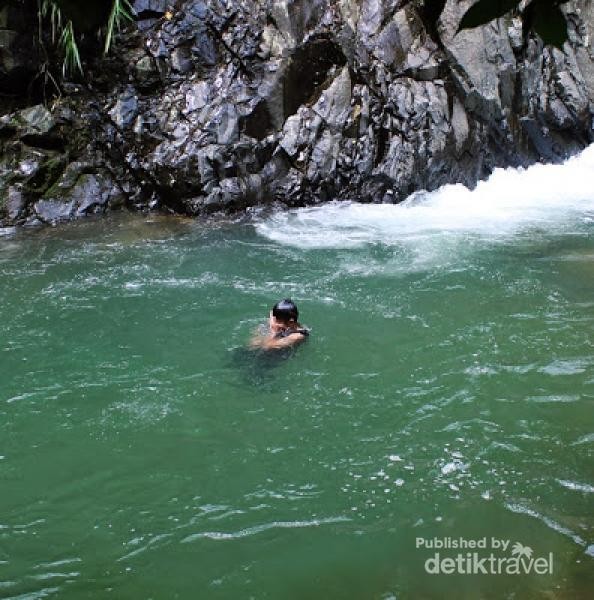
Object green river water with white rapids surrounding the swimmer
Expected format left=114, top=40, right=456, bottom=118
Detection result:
left=0, top=147, right=594, bottom=599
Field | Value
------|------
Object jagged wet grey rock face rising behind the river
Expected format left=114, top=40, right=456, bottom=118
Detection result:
left=0, top=0, right=594, bottom=227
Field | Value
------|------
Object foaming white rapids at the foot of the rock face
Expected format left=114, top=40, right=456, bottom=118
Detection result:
left=256, top=145, right=594, bottom=248
